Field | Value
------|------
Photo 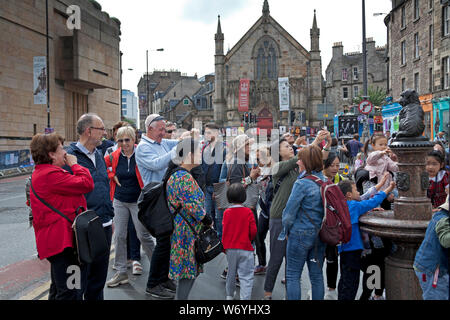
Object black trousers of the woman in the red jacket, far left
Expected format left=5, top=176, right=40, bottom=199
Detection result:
left=47, top=248, right=81, bottom=300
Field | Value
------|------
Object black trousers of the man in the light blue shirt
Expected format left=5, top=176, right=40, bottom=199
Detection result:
left=147, top=235, right=171, bottom=289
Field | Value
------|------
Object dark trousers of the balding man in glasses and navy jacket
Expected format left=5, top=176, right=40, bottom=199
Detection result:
left=81, top=226, right=112, bottom=300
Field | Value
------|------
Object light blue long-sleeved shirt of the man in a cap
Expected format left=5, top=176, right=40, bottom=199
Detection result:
left=136, top=135, right=178, bottom=186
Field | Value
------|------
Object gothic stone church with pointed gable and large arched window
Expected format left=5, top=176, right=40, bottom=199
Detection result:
left=213, top=0, right=323, bottom=129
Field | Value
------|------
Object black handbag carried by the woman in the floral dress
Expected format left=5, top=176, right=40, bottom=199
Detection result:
left=179, top=212, right=223, bottom=264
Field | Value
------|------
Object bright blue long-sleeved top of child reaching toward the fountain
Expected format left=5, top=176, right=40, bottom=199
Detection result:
left=338, top=191, right=386, bottom=253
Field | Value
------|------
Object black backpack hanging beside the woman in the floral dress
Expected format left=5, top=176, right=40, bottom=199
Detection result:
left=137, top=167, right=186, bottom=237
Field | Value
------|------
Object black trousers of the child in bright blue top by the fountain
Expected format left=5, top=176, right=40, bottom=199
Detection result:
left=338, top=250, right=362, bottom=300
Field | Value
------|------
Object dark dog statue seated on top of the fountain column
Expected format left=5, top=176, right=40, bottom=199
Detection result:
left=395, top=89, right=425, bottom=139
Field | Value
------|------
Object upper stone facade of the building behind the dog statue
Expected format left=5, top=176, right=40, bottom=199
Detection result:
left=385, top=0, right=450, bottom=100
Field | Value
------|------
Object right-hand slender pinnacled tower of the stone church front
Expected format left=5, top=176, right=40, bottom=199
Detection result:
left=306, top=10, right=322, bottom=126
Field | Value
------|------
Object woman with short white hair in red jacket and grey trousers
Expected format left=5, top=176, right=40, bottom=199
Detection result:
left=105, top=126, right=155, bottom=287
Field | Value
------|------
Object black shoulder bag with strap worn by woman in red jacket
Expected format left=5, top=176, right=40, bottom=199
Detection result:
left=30, top=181, right=110, bottom=264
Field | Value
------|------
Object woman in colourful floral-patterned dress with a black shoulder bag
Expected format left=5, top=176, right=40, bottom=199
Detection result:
left=165, top=138, right=212, bottom=300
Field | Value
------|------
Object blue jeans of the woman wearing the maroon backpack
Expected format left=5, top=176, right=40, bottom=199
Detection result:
left=286, top=229, right=325, bottom=300
